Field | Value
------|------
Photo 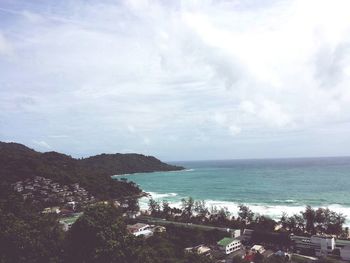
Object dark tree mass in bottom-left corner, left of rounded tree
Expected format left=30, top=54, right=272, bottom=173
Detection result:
left=0, top=184, right=63, bottom=263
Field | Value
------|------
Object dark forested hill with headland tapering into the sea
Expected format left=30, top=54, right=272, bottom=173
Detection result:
left=0, top=142, right=182, bottom=198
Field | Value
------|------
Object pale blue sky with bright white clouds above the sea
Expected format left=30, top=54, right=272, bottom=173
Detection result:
left=0, top=0, right=350, bottom=161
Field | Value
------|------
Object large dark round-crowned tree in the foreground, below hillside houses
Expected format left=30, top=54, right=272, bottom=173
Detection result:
left=65, top=204, right=135, bottom=263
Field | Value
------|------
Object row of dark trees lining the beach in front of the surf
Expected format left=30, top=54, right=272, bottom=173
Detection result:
left=149, top=197, right=348, bottom=238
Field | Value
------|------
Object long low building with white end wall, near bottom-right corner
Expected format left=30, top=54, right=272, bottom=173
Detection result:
left=290, top=235, right=335, bottom=257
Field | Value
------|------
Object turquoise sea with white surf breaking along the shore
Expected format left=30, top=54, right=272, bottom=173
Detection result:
left=114, top=157, right=350, bottom=226
